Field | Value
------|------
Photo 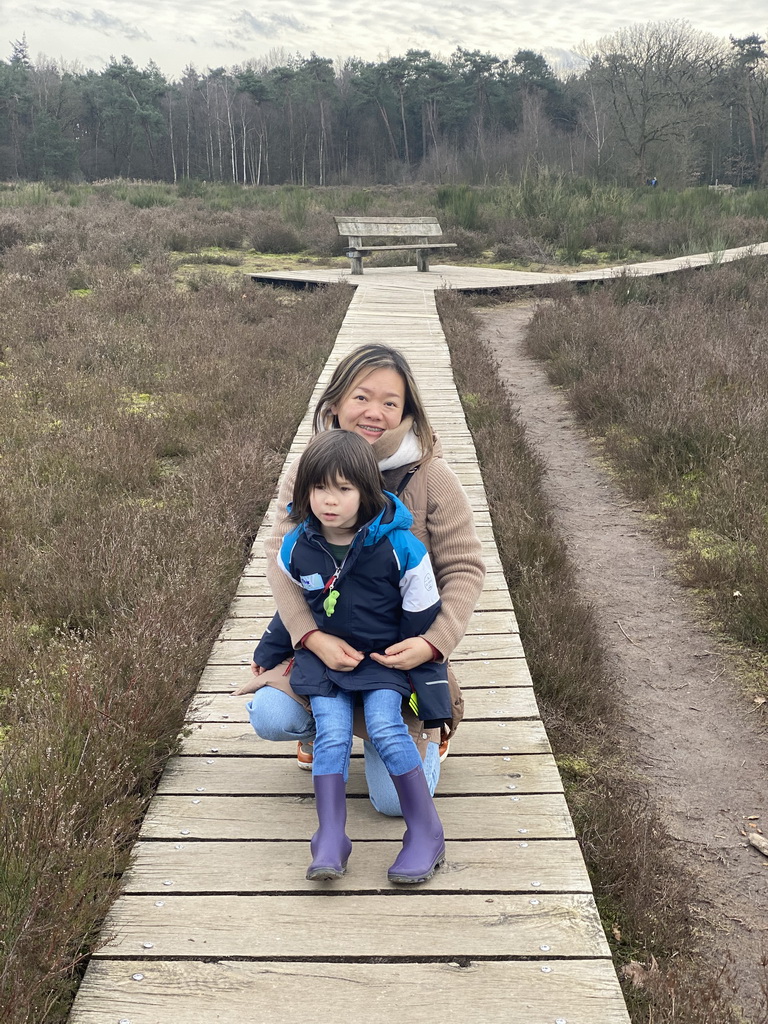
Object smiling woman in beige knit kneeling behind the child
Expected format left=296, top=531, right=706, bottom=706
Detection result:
left=238, top=344, right=485, bottom=815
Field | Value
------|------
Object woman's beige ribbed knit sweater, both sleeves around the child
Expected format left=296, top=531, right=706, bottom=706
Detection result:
left=264, top=420, right=485, bottom=658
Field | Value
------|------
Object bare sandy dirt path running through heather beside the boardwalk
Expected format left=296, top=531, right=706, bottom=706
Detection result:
left=478, top=305, right=768, bottom=1020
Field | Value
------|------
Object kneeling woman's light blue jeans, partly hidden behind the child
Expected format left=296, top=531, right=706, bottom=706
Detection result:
left=246, top=686, right=440, bottom=817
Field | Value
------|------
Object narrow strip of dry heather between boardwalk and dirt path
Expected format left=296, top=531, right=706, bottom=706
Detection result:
left=440, top=293, right=739, bottom=1024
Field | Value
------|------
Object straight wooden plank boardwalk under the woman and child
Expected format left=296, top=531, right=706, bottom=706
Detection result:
left=70, top=284, right=629, bottom=1024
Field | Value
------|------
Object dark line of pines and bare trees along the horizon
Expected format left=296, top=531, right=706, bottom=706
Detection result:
left=0, top=20, right=768, bottom=185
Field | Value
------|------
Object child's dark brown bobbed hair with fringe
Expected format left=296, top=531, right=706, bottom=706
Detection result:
left=288, top=430, right=386, bottom=526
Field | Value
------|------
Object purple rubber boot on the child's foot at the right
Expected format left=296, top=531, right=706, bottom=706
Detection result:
left=387, top=765, right=445, bottom=886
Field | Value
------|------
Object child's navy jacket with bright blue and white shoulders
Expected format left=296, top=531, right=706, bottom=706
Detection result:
left=254, top=494, right=453, bottom=728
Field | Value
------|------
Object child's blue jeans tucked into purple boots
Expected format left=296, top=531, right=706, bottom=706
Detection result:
left=309, top=687, right=421, bottom=781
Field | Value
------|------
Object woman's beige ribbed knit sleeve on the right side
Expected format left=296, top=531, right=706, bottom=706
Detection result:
left=423, top=459, right=485, bottom=658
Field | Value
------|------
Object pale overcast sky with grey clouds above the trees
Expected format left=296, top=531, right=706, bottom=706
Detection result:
left=6, top=0, right=768, bottom=78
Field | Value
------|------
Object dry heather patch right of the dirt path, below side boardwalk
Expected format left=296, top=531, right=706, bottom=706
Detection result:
left=529, top=259, right=768, bottom=671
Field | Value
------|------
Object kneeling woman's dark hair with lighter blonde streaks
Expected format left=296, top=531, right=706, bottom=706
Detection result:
left=313, top=342, right=433, bottom=455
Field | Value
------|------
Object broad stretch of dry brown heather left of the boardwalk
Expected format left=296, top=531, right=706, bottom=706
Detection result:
left=0, top=211, right=347, bottom=1024
